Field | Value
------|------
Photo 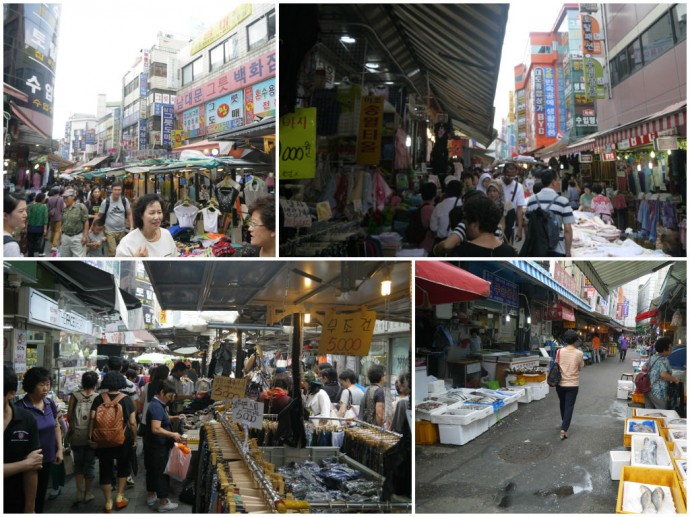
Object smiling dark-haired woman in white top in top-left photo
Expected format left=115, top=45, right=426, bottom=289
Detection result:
left=115, top=194, right=178, bottom=257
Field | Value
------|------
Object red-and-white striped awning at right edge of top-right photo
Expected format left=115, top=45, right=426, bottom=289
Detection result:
left=595, top=101, right=687, bottom=151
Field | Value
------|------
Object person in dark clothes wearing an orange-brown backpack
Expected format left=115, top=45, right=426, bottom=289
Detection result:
left=89, top=371, right=137, bottom=513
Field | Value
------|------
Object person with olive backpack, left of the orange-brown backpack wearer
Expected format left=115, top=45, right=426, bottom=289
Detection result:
left=67, top=371, right=98, bottom=506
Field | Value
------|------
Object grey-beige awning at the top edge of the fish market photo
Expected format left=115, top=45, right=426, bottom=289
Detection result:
left=573, top=260, right=673, bottom=296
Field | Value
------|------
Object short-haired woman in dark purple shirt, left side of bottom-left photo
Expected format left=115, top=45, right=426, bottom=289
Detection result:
left=19, top=366, right=64, bottom=513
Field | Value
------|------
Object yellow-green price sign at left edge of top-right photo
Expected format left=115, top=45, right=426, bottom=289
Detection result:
left=278, top=108, right=316, bottom=180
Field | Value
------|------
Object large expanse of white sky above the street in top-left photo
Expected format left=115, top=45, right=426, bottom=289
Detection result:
left=53, top=0, right=242, bottom=139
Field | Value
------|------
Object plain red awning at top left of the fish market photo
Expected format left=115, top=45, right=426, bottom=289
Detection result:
left=415, top=260, right=491, bottom=305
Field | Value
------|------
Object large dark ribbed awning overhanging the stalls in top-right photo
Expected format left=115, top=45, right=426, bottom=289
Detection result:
left=312, top=3, right=509, bottom=146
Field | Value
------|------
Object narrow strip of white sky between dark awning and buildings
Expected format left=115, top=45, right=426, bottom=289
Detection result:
left=494, top=0, right=563, bottom=132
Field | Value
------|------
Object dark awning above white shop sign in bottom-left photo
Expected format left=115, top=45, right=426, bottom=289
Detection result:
left=43, top=261, right=141, bottom=310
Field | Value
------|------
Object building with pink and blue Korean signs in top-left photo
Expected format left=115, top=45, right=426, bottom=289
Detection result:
left=174, top=4, right=276, bottom=152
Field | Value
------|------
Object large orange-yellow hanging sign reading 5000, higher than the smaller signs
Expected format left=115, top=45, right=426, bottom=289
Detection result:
left=318, top=311, right=376, bottom=356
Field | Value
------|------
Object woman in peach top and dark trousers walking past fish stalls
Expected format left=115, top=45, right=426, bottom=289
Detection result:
left=556, top=330, right=584, bottom=440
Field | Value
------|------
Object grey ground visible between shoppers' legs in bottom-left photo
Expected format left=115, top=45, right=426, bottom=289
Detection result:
left=44, top=439, right=192, bottom=514
